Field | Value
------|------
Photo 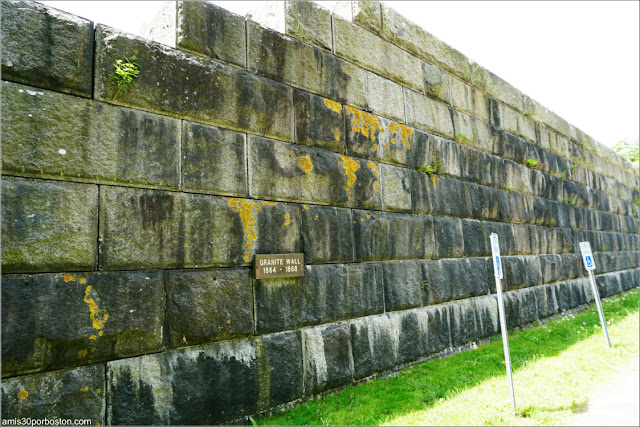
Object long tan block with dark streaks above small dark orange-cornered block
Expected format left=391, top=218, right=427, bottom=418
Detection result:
left=247, top=21, right=365, bottom=106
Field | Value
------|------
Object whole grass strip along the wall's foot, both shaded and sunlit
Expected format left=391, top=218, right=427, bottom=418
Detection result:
left=258, top=289, right=638, bottom=425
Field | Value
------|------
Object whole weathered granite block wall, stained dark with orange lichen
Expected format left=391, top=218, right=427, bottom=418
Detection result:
left=1, top=0, right=640, bottom=424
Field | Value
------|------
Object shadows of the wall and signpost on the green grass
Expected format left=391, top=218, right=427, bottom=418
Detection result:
left=258, top=291, right=638, bottom=425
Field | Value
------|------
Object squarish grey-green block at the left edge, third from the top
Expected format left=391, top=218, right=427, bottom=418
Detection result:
left=2, top=177, right=98, bottom=273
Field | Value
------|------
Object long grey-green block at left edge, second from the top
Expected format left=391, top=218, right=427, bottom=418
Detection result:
left=2, top=82, right=180, bottom=189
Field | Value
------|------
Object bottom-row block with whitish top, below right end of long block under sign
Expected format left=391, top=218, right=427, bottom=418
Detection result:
left=350, top=314, right=398, bottom=379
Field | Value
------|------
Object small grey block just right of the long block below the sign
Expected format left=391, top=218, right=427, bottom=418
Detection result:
left=382, top=261, right=423, bottom=311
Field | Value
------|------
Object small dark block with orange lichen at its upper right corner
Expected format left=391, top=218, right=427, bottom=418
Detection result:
left=293, top=90, right=346, bottom=153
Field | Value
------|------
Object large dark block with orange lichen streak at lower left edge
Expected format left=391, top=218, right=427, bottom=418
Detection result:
left=2, top=271, right=165, bottom=375
